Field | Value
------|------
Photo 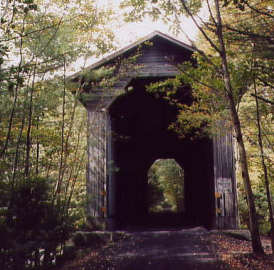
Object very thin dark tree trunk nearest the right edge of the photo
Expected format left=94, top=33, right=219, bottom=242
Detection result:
left=253, top=77, right=274, bottom=254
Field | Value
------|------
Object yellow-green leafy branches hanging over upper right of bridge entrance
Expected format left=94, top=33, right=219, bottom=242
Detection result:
left=147, top=58, right=227, bottom=139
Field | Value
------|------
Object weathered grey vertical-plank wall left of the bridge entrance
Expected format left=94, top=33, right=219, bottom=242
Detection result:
left=87, top=109, right=115, bottom=230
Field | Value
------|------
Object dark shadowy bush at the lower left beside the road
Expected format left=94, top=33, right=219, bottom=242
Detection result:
left=0, top=178, right=72, bottom=269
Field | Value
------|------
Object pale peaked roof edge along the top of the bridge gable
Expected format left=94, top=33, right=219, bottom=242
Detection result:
left=70, top=31, right=195, bottom=80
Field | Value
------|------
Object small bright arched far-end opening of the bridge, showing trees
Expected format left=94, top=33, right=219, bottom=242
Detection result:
left=147, top=159, right=187, bottom=227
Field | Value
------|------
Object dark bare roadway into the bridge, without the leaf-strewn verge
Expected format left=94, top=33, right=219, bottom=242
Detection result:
left=103, top=229, right=225, bottom=270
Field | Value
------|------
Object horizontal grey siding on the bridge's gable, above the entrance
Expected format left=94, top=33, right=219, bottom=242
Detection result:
left=83, top=37, right=192, bottom=108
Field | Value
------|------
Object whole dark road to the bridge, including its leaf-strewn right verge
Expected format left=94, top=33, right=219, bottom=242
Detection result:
left=61, top=227, right=274, bottom=270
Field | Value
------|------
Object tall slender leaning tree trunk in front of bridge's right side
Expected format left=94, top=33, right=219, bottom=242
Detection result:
left=214, top=0, right=264, bottom=254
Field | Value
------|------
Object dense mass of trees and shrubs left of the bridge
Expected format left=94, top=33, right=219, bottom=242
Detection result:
left=0, top=0, right=113, bottom=270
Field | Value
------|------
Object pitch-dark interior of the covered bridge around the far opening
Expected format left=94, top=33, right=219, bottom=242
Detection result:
left=109, top=79, right=215, bottom=229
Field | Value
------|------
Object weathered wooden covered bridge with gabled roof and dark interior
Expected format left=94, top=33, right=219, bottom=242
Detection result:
left=72, top=31, right=237, bottom=229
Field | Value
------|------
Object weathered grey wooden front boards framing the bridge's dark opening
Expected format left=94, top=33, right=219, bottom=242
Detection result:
left=73, top=31, right=237, bottom=229
